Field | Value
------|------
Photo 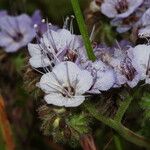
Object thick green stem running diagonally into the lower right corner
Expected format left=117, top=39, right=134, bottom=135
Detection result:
left=84, top=103, right=150, bottom=149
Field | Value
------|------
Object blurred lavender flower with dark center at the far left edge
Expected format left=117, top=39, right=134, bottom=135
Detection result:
left=0, top=14, right=35, bottom=52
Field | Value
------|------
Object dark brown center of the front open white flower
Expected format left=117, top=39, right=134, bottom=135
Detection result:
left=62, top=86, right=75, bottom=98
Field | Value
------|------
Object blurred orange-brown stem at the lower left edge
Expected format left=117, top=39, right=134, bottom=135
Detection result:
left=0, top=95, right=15, bottom=150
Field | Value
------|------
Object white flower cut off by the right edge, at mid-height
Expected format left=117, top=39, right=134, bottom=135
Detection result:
left=128, top=44, right=150, bottom=80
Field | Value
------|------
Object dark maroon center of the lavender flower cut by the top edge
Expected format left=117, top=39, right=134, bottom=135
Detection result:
left=115, top=0, right=128, bottom=14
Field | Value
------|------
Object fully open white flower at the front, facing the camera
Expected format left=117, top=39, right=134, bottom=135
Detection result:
left=38, top=61, right=93, bottom=107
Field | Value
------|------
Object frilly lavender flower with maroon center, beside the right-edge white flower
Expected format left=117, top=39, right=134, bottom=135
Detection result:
left=94, top=41, right=139, bottom=87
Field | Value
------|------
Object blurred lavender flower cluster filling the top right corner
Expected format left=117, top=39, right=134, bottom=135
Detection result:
left=96, top=0, right=150, bottom=35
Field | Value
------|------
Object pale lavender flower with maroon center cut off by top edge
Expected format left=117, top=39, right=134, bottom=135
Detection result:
left=101, top=0, right=143, bottom=18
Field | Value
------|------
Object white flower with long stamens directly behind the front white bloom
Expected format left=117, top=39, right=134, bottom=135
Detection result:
left=28, top=29, right=83, bottom=68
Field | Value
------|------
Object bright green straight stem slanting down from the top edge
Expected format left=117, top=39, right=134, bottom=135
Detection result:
left=71, top=0, right=96, bottom=61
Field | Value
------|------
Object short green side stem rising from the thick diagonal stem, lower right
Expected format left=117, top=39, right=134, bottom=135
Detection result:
left=114, top=96, right=133, bottom=123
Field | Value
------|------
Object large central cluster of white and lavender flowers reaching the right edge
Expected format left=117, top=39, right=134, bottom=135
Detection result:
left=28, top=19, right=150, bottom=107
